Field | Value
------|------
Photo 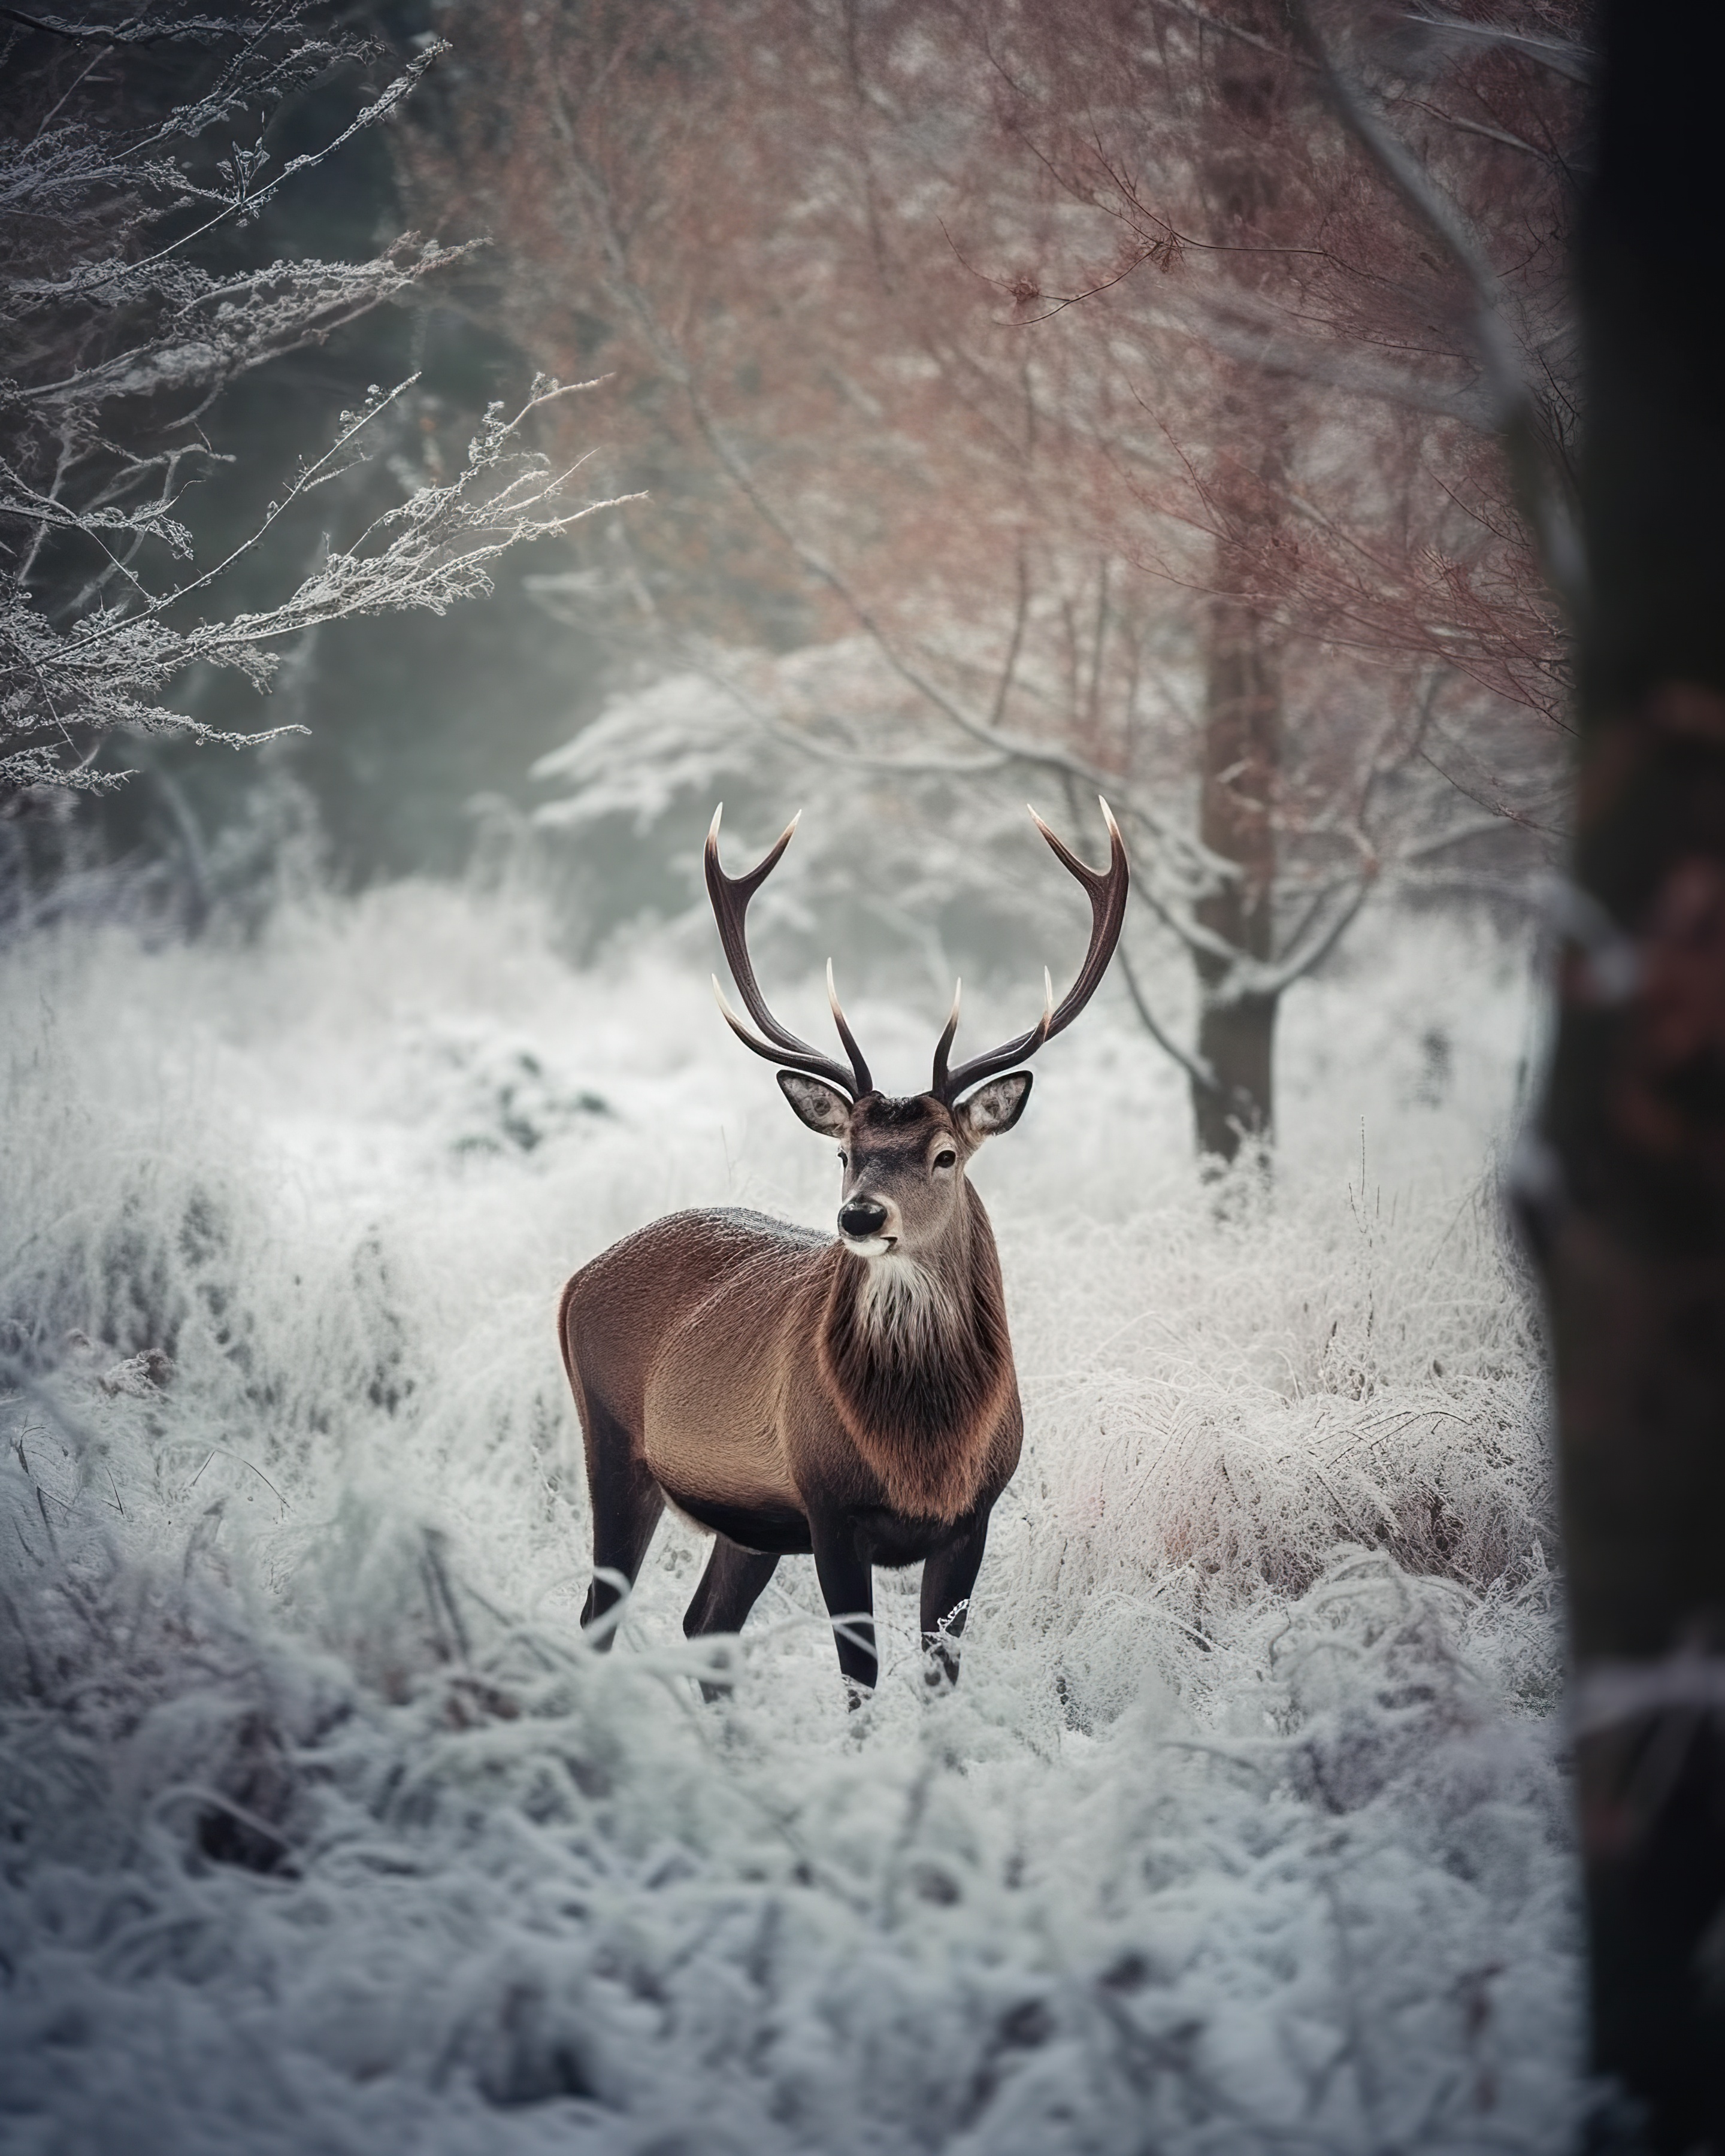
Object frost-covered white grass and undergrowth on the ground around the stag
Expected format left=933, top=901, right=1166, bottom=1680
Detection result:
left=0, top=886, right=1578, bottom=2156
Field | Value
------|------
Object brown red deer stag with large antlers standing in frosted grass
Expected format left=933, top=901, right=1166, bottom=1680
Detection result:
left=558, top=802, right=1128, bottom=1706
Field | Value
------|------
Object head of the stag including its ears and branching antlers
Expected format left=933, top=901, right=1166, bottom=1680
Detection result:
left=707, top=802, right=1130, bottom=1259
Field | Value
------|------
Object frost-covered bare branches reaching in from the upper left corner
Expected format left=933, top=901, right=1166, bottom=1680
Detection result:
left=0, top=0, right=630, bottom=791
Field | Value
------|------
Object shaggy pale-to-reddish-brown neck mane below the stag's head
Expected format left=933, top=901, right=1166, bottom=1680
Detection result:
left=819, top=1183, right=1013, bottom=1520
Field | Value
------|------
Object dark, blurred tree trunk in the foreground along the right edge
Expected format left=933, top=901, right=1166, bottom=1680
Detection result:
left=1524, top=0, right=1725, bottom=2152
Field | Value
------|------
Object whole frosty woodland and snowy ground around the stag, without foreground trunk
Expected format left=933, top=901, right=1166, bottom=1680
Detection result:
left=0, top=0, right=1587, bottom=2156
